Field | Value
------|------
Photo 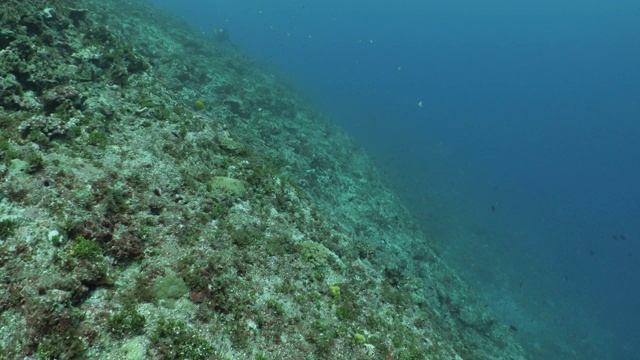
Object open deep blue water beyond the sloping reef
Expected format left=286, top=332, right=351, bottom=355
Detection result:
left=151, top=0, right=640, bottom=359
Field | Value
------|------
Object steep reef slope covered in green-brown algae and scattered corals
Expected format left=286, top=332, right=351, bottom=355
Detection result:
left=0, top=0, right=526, bottom=359
